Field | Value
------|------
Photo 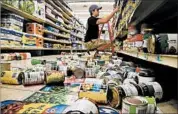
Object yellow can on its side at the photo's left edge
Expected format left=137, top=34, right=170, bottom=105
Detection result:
left=0, top=71, right=22, bottom=85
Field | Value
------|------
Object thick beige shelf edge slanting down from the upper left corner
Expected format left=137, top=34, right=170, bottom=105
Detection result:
left=0, top=2, right=45, bottom=23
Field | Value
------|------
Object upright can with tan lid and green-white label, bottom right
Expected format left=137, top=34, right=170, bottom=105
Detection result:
left=122, top=96, right=148, bottom=114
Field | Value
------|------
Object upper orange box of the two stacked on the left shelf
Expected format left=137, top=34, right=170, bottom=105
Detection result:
left=26, top=23, right=44, bottom=36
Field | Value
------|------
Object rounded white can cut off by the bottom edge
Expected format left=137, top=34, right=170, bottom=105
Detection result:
left=62, top=99, right=99, bottom=114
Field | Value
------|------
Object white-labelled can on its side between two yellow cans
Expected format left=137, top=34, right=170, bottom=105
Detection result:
left=23, top=71, right=45, bottom=85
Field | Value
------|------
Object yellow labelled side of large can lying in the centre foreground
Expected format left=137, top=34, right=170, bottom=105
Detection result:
left=79, top=83, right=108, bottom=104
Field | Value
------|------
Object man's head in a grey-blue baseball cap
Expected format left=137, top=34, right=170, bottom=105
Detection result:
left=89, top=5, right=102, bottom=17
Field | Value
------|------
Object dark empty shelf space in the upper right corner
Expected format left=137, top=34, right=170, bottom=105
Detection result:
left=131, top=0, right=178, bottom=33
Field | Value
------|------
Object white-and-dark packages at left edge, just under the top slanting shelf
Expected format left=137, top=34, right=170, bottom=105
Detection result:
left=1, top=12, right=24, bottom=32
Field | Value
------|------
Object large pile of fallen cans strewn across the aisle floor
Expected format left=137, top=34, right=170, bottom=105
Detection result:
left=1, top=53, right=163, bottom=114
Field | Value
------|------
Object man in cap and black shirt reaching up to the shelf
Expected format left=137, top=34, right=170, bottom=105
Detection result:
left=85, top=5, right=119, bottom=54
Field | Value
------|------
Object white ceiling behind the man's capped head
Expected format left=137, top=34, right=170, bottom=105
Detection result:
left=68, top=0, right=114, bottom=25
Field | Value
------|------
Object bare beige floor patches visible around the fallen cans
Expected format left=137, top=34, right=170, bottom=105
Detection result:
left=0, top=56, right=178, bottom=113
